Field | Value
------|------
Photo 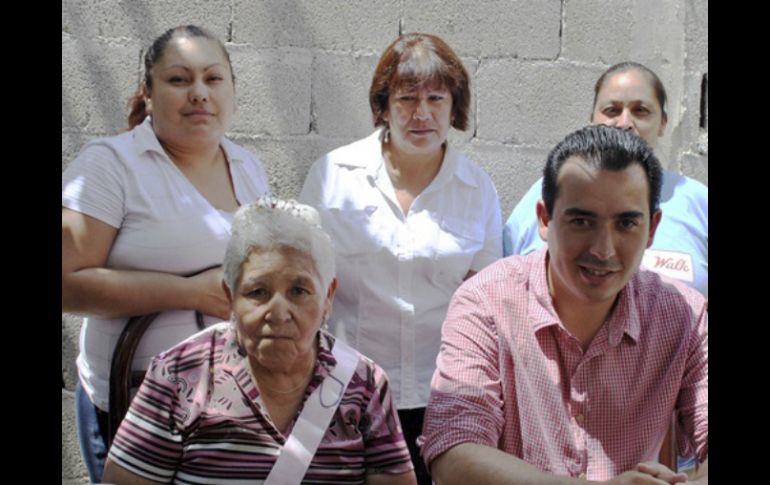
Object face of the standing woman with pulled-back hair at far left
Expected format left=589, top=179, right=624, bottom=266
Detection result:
left=148, top=37, right=235, bottom=147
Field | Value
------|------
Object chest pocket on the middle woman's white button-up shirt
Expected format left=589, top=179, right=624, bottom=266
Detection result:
left=433, top=216, right=484, bottom=291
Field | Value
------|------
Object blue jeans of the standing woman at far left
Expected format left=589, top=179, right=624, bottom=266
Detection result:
left=75, top=381, right=109, bottom=483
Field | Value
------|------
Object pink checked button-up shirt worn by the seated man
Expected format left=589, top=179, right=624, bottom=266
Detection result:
left=422, top=248, right=708, bottom=480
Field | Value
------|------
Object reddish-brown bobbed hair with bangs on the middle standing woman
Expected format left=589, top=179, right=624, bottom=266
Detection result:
left=369, top=33, right=471, bottom=131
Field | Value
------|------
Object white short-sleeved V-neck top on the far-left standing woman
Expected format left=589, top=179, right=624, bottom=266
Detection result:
left=62, top=118, right=269, bottom=410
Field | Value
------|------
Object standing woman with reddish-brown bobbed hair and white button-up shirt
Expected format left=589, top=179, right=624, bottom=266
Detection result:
left=300, top=34, right=502, bottom=483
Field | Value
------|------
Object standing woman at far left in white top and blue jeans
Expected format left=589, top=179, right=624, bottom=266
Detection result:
left=62, top=26, right=269, bottom=482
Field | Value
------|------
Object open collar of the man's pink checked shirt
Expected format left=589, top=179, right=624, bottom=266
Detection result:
left=526, top=246, right=641, bottom=347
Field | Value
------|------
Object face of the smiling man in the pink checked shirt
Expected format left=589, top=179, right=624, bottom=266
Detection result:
left=537, top=157, right=661, bottom=307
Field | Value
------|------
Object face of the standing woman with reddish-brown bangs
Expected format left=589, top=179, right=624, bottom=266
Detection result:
left=384, top=85, right=452, bottom=155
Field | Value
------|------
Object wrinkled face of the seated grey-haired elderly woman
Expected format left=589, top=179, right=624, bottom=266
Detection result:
left=233, top=248, right=333, bottom=372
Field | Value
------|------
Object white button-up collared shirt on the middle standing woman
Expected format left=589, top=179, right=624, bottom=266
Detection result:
left=300, top=130, right=502, bottom=409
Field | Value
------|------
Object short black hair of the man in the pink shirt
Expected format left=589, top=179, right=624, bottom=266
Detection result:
left=542, top=125, right=663, bottom=217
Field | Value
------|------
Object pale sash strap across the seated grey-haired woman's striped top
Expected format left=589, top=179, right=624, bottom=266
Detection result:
left=265, top=339, right=358, bottom=485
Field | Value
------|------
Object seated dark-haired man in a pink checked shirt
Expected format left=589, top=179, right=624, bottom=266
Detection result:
left=422, top=126, right=708, bottom=485
